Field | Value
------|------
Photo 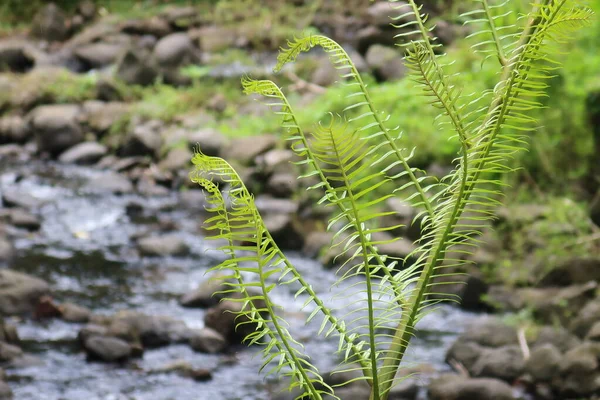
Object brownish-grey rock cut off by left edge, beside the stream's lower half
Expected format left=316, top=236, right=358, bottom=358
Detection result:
left=0, top=269, right=50, bottom=315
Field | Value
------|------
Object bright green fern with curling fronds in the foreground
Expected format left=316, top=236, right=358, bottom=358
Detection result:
left=191, top=0, right=592, bottom=400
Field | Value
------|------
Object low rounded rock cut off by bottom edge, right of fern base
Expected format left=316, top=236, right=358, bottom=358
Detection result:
left=429, top=375, right=514, bottom=400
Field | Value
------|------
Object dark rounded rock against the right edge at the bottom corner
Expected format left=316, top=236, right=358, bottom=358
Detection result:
left=556, top=343, right=600, bottom=398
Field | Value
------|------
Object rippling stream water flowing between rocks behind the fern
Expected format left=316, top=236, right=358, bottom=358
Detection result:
left=0, top=162, right=475, bottom=400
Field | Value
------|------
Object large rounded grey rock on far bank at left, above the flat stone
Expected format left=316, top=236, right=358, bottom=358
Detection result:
left=27, top=104, right=83, bottom=155
